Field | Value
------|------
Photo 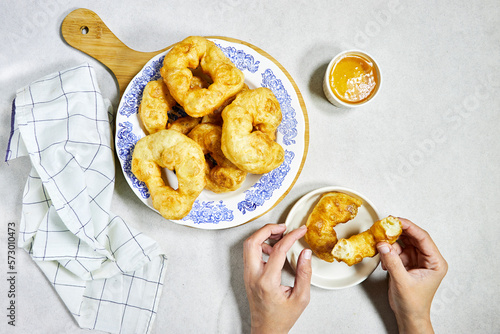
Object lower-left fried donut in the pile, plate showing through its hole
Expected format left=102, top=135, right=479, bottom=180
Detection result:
left=132, top=130, right=206, bottom=219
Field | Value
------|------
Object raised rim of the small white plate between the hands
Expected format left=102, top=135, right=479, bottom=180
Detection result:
left=285, top=186, right=381, bottom=290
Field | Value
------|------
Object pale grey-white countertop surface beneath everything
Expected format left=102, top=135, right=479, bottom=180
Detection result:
left=0, top=0, right=500, bottom=333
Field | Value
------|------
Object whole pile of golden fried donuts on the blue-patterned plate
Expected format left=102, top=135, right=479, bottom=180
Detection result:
left=132, top=36, right=284, bottom=219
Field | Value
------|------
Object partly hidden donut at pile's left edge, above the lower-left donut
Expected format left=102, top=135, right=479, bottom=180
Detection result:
left=138, top=79, right=177, bottom=134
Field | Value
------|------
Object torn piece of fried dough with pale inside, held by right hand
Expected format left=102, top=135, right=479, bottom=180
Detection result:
left=332, top=216, right=403, bottom=266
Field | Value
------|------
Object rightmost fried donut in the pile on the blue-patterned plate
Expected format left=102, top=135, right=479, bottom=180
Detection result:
left=221, top=87, right=285, bottom=174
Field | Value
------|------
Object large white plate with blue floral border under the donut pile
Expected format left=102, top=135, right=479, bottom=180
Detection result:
left=115, top=38, right=308, bottom=229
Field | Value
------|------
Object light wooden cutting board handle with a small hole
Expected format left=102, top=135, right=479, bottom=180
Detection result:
left=61, top=8, right=166, bottom=96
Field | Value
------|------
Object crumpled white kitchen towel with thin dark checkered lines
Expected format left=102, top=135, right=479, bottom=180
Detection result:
left=6, top=64, right=166, bottom=333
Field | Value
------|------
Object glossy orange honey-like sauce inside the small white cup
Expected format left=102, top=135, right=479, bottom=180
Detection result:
left=330, top=53, right=378, bottom=103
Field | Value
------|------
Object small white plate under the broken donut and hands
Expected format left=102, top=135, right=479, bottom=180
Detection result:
left=285, top=187, right=380, bottom=289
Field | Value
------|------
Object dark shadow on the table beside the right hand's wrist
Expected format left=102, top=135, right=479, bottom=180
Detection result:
left=361, top=275, right=398, bottom=333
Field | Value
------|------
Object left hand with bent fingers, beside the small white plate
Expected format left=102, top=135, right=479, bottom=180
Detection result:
left=243, top=224, right=311, bottom=333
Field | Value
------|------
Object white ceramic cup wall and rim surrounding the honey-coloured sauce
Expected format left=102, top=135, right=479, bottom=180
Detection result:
left=323, top=50, right=382, bottom=108
